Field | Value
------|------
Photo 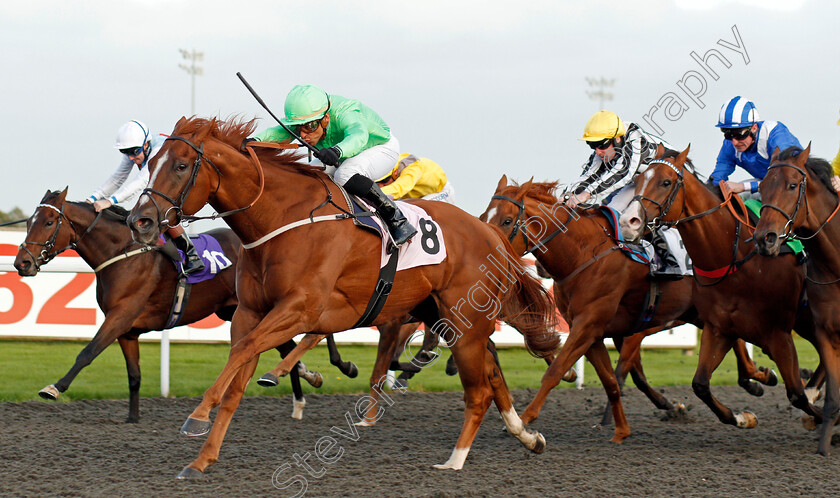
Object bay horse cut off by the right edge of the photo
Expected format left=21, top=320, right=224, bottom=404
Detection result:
left=755, top=144, right=840, bottom=455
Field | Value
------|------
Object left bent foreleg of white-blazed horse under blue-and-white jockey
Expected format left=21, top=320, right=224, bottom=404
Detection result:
left=691, top=324, right=752, bottom=429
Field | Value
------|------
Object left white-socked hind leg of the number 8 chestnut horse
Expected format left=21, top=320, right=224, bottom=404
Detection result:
left=434, top=336, right=496, bottom=470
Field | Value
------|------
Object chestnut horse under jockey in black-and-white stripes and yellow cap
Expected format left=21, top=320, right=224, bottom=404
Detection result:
left=481, top=176, right=776, bottom=436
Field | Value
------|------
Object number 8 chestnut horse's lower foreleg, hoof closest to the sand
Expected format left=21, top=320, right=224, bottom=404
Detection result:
left=178, top=355, right=260, bottom=479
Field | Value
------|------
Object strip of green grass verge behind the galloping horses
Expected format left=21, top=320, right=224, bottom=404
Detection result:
left=0, top=337, right=818, bottom=401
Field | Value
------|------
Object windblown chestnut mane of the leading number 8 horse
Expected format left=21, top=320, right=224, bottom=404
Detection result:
left=172, top=117, right=324, bottom=176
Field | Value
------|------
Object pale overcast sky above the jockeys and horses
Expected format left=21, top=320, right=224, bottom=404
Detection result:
left=0, top=0, right=840, bottom=225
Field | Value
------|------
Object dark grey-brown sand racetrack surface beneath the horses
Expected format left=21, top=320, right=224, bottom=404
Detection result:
left=0, top=386, right=840, bottom=497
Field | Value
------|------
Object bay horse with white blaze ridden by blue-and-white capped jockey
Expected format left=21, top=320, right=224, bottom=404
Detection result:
left=621, top=147, right=820, bottom=434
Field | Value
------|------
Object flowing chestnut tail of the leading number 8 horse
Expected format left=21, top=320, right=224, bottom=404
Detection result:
left=497, top=238, right=560, bottom=358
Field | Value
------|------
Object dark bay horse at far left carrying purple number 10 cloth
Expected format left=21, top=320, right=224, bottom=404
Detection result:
left=15, top=188, right=330, bottom=422
